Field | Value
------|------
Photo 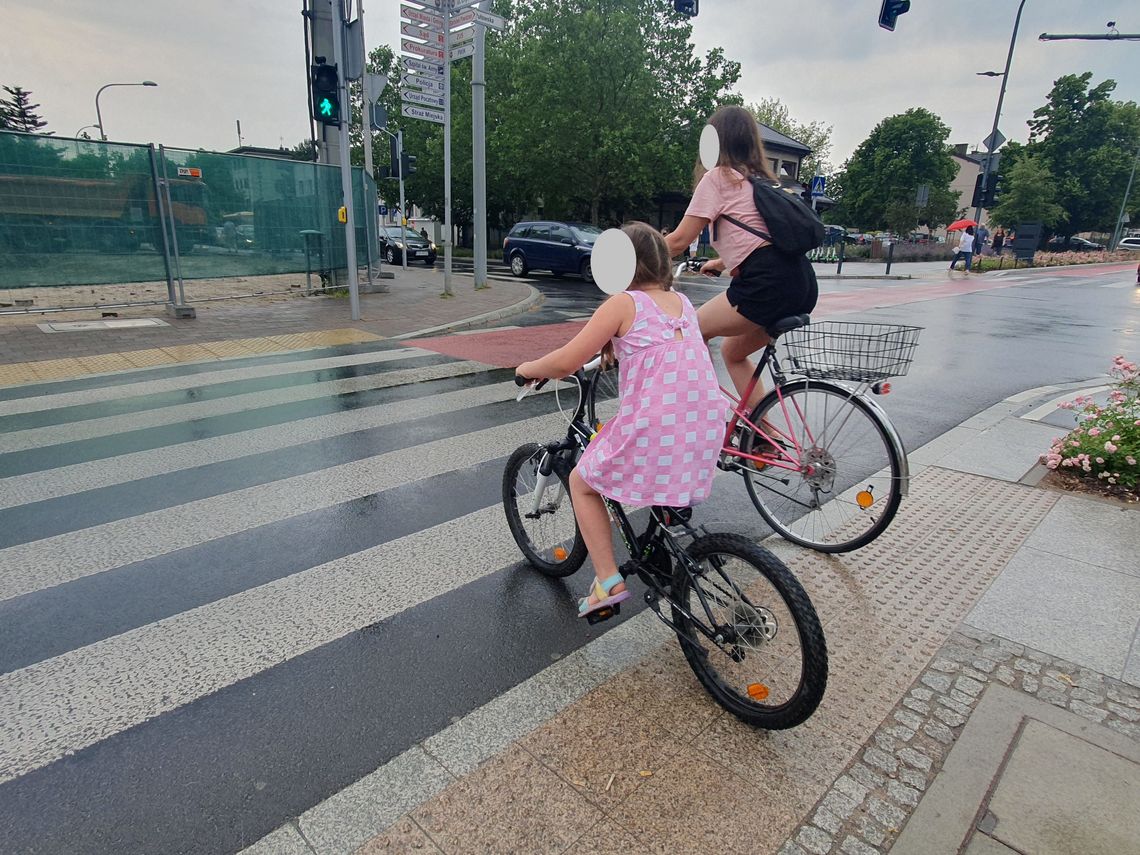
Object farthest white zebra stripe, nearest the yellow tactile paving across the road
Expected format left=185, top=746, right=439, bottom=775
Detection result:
left=0, top=348, right=434, bottom=416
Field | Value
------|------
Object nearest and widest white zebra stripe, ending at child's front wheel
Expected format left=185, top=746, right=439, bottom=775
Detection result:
left=0, top=505, right=520, bottom=783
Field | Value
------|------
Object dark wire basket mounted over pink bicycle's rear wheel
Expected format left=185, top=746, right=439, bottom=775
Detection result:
left=781, top=320, right=922, bottom=383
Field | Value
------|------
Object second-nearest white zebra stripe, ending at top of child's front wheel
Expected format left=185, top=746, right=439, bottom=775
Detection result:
left=0, top=413, right=564, bottom=601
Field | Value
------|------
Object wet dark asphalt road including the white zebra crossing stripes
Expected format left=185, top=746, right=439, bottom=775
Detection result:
left=0, top=269, right=1140, bottom=853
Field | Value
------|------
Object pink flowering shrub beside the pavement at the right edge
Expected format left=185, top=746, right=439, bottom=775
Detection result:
left=1041, top=356, right=1140, bottom=490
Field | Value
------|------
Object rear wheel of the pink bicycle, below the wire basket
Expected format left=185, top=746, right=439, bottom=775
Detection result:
left=741, top=380, right=903, bottom=553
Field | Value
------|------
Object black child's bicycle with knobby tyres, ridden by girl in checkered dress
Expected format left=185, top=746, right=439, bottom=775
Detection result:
left=503, top=358, right=828, bottom=730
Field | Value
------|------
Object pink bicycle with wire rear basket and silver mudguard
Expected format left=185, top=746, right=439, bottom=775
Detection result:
left=587, top=315, right=921, bottom=553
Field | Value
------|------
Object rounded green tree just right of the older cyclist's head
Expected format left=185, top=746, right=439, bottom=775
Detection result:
left=834, top=107, right=956, bottom=234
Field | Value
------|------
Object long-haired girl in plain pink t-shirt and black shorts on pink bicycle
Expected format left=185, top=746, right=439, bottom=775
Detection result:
left=666, top=106, right=819, bottom=407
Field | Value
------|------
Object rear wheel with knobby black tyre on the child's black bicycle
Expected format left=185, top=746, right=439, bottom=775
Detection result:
left=673, top=534, right=828, bottom=731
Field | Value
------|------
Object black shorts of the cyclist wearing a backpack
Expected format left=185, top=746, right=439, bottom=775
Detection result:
left=727, top=245, right=820, bottom=328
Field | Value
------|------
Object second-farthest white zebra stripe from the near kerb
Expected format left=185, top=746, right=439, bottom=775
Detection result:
left=0, top=361, right=489, bottom=454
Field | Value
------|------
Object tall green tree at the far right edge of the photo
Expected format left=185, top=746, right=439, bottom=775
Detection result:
left=1026, top=72, right=1140, bottom=236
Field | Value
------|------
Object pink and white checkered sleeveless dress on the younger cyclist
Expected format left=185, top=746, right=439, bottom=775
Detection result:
left=578, top=291, right=728, bottom=507
